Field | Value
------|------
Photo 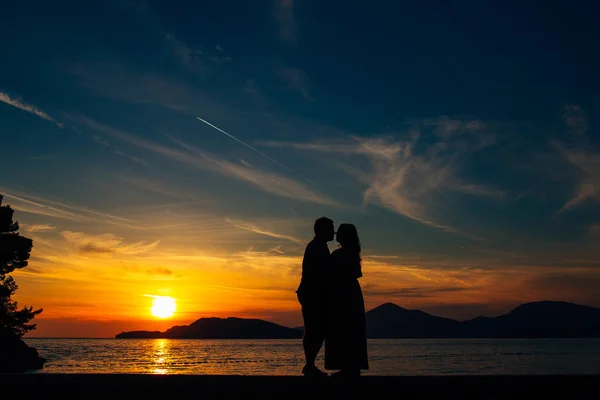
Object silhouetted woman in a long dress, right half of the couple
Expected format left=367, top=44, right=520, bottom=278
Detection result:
left=325, top=224, right=369, bottom=378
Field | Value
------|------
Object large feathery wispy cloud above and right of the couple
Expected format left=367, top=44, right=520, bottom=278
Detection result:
left=264, top=117, right=504, bottom=232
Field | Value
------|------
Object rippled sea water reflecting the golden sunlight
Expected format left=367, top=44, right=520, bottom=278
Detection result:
left=25, top=338, right=600, bottom=375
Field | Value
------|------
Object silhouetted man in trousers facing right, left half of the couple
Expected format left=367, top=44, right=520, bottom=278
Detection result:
left=296, top=217, right=335, bottom=377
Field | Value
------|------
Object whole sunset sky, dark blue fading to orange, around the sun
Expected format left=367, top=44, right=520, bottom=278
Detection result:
left=0, top=0, right=600, bottom=337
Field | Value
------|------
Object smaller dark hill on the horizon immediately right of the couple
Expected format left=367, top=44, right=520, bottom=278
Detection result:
left=366, top=303, right=460, bottom=339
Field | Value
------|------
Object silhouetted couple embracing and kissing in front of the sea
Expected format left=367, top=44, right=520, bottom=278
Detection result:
left=296, top=217, right=369, bottom=378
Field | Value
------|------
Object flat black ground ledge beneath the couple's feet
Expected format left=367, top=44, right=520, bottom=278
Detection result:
left=0, top=374, right=600, bottom=400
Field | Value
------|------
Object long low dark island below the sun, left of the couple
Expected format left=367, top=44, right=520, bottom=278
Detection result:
left=116, top=317, right=303, bottom=339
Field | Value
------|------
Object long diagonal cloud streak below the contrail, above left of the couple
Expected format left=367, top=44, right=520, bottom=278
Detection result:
left=78, top=117, right=339, bottom=206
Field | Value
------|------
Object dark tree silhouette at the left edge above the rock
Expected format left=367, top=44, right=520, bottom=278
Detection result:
left=0, top=195, right=42, bottom=338
